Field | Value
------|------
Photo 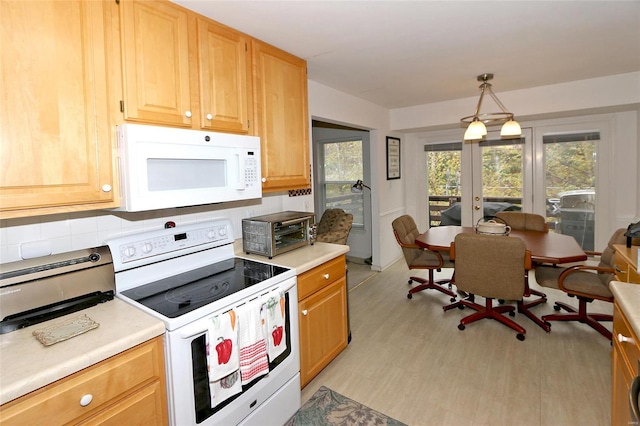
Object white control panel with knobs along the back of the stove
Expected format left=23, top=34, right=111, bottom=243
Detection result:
left=108, top=220, right=234, bottom=264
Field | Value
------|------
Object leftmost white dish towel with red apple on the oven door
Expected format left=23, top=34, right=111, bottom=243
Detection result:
left=207, top=309, right=240, bottom=382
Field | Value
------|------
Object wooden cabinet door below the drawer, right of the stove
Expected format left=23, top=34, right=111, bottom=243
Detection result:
left=298, top=278, right=348, bottom=387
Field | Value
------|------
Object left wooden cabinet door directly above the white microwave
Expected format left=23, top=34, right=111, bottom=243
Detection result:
left=120, top=0, right=192, bottom=127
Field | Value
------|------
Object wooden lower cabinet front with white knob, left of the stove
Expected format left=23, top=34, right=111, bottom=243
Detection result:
left=0, top=337, right=168, bottom=426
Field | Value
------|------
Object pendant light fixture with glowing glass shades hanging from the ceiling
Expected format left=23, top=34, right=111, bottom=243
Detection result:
left=460, top=74, right=522, bottom=140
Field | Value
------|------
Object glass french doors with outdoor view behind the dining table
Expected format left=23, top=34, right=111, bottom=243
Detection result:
left=425, top=124, right=607, bottom=250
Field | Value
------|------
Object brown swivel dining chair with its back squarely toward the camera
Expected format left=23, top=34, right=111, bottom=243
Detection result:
left=450, top=233, right=531, bottom=340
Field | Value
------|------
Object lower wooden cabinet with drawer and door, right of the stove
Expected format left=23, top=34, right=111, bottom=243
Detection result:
left=298, top=255, right=349, bottom=387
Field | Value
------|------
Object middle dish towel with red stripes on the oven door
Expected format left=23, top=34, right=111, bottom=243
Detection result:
left=237, top=299, right=269, bottom=385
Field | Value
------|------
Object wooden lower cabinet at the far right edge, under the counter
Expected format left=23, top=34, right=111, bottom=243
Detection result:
left=611, top=302, right=640, bottom=426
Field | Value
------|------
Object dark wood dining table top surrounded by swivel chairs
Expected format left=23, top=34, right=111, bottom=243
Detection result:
left=416, top=226, right=587, bottom=264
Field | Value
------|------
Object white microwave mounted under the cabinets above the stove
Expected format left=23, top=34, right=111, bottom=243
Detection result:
left=116, top=124, right=262, bottom=212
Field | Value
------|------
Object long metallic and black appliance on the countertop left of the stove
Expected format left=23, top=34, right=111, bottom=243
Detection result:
left=0, top=246, right=115, bottom=334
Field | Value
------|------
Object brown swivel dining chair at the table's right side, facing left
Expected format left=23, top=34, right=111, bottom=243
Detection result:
left=534, top=228, right=626, bottom=340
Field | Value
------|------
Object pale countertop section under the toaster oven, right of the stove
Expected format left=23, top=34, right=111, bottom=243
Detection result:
left=233, top=240, right=349, bottom=275
